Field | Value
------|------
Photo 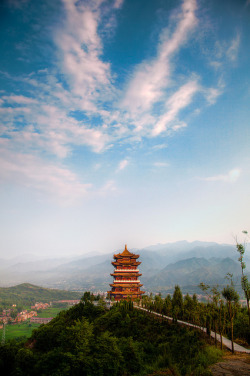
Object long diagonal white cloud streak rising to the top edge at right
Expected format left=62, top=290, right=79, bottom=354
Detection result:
left=122, top=0, right=197, bottom=113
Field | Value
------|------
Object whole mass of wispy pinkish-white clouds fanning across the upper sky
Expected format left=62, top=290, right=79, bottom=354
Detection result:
left=0, top=0, right=236, bottom=204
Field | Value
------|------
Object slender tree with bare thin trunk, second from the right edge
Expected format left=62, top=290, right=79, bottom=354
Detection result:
left=222, top=273, right=239, bottom=353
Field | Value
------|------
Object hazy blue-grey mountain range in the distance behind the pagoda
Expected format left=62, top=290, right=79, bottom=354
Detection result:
left=0, top=241, right=250, bottom=292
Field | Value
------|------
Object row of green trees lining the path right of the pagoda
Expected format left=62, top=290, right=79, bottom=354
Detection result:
left=142, top=284, right=250, bottom=352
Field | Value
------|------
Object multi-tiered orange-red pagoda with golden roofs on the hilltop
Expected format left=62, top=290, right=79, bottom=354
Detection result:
left=108, top=245, right=145, bottom=300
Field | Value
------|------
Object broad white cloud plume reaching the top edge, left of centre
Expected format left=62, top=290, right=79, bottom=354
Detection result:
left=55, top=0, right=111, bottom=111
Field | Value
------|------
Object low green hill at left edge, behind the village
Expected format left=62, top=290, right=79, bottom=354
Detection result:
left=0, top=283, right=82, bottom=309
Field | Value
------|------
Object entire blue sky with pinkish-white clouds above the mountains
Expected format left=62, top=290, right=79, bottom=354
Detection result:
left=0, top=0, right=250, bottom=257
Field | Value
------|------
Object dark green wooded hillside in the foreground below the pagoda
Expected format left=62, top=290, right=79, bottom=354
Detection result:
left=0, top=301, right=223, bottom=376
